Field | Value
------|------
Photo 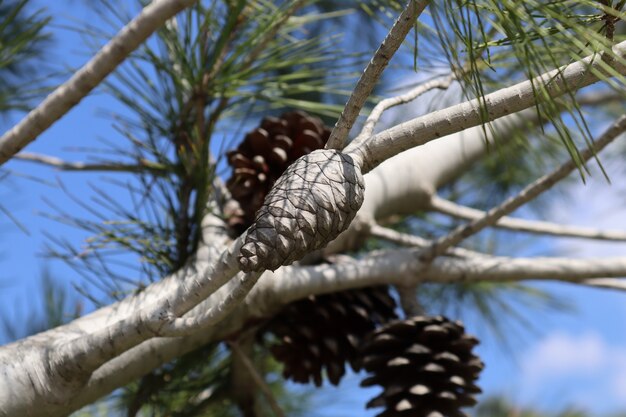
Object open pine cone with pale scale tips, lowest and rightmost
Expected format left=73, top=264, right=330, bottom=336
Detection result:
left=361, top=316, right=484, bottom=417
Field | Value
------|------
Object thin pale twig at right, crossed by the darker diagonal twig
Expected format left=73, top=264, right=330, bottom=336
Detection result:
left=430, top=195, right=626, bottom=241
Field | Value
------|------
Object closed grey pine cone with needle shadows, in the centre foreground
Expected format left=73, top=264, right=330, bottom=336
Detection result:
left=238, top=149, right=364, bottom=272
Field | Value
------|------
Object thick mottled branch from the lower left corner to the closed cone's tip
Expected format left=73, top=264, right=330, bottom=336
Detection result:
left=0, top=229, right=241, bottom=416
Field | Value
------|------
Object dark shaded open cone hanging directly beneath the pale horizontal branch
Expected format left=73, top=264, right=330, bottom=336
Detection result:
left=268, top=286, right=397, bottom=387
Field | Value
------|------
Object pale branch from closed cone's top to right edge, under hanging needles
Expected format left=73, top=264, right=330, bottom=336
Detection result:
left=344, top=41, right=626, bottom=173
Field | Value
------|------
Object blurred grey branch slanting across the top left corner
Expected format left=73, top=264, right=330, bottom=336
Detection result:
left=0, top=0, right=196, bottom=165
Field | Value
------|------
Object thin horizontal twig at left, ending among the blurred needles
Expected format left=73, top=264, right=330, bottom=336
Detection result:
left=14, top=152, right=167, bottom=174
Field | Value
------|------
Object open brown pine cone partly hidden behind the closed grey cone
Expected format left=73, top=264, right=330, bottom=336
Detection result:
left=226, top=111, right=330, bottom=233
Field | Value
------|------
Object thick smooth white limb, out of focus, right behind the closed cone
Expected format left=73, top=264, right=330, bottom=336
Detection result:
left=334, top=87, right=621, bottom=253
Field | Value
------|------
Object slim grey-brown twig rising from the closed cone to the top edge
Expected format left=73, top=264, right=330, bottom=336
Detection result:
left=326, top=0, right=429, bottom=149
